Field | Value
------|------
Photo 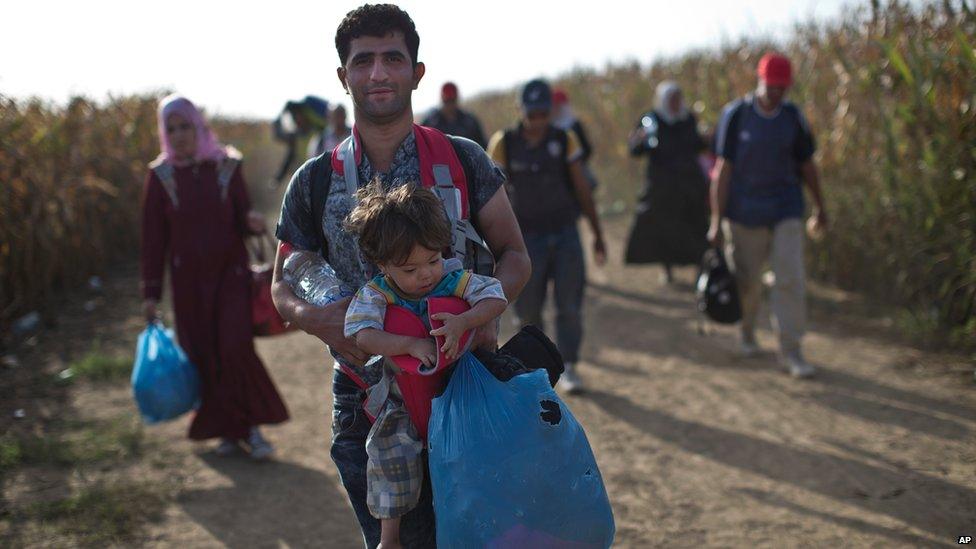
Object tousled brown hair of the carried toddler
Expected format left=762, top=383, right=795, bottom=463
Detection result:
left=344, top=180, right=451, bottom=265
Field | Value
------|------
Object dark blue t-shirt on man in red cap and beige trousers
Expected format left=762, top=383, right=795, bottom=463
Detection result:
left=716, top=96, right=816, bottom=227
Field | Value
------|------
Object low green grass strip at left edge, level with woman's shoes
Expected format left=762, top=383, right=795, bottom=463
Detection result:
left=0, top=417, right=146, bottom=474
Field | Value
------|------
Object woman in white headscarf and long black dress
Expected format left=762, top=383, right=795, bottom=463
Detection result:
left=624, top=80, right=708, bottom=284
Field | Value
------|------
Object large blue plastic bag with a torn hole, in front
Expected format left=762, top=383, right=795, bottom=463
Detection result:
left=428, top=353, right=614, bottom=549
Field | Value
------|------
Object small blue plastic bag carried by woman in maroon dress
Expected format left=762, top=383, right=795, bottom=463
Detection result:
left=132, top=322, right=200, bottom=425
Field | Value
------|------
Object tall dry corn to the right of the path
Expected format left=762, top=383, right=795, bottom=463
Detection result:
left=469, top=1, right=976, bottom=347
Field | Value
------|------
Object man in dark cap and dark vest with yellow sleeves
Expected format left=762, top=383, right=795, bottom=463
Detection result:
left=488, top=80, right=606, bottom=393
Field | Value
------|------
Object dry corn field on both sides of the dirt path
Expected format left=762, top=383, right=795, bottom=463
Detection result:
left=0, top=0, right=976, bottom=347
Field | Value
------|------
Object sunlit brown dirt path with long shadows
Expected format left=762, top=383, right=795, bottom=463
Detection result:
left=40, top=222, right=976, bottom=548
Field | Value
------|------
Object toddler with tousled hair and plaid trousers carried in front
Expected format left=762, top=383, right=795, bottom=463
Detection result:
left=345, top=181, right=508, bottom=548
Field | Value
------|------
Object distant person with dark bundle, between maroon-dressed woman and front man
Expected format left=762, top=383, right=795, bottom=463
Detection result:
left=271, top=95, right=329, bottom=188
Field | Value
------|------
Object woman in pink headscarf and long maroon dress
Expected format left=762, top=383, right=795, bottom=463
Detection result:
left=142, top=95, right=288, bottom=459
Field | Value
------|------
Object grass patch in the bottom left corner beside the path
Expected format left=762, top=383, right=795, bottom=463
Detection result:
left=9, top=482, right=166, bottom=547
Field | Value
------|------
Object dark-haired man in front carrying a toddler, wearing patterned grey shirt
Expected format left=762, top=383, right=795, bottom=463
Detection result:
left=273, top=4, right=530, bottom=547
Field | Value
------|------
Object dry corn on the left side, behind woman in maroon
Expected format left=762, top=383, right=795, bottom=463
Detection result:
left=0, top=94, right=281, bottom=333
